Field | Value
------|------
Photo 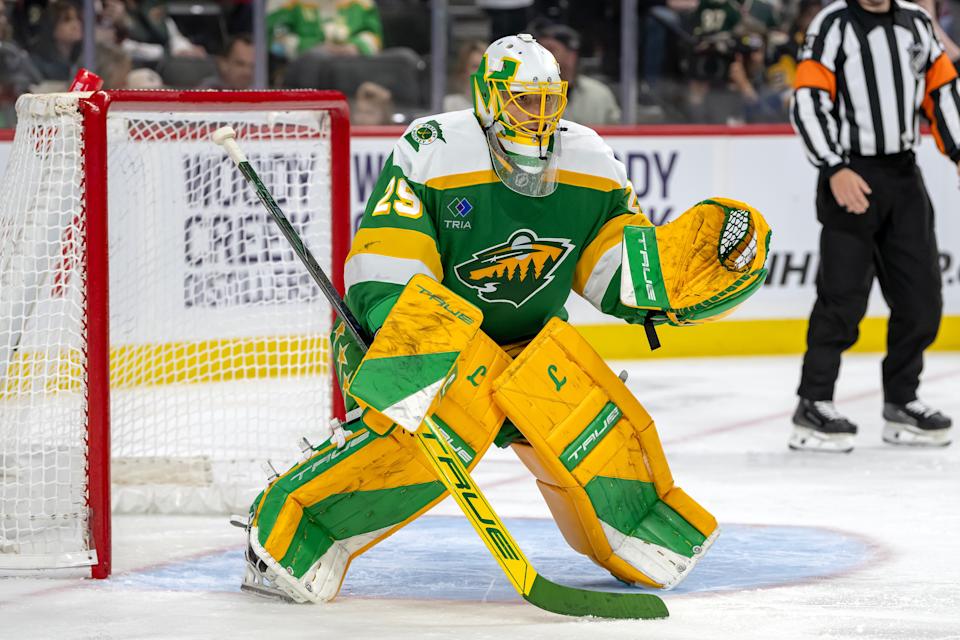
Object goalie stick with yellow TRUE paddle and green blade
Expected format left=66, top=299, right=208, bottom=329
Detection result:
left=213, top=127, right=669, bottom=619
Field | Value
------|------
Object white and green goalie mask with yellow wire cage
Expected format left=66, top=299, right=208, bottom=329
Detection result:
left=471, top=33, right=567, bottom=197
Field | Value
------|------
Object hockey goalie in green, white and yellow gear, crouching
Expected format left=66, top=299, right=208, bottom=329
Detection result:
left=243, top=34, right=770, bottom=602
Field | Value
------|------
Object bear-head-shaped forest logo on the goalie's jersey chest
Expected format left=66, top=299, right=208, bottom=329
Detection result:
left=454, top=229, right=574, bottom=307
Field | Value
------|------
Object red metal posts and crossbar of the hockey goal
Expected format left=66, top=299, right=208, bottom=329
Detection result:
left=78, top=89, right=350, bottom=579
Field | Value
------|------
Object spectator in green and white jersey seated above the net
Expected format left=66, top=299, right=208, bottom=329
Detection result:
left=267, top=0, right=383, bottom=60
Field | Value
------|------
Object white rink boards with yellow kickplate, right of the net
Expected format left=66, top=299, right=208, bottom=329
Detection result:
left=0, top=125, right=960, bottom=358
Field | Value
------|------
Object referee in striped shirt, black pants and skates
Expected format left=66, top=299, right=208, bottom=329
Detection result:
left=790, top=0, right=960, bottom=452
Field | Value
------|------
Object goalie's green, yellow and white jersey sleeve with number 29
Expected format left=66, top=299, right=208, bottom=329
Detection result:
left=344, top=149, right=443, bottom=335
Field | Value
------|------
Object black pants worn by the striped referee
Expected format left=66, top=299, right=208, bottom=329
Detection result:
left=797, top=152, right=943, bottom=404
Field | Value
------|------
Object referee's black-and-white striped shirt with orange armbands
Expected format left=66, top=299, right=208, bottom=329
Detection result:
left=790, top=0, right=960, bottom=174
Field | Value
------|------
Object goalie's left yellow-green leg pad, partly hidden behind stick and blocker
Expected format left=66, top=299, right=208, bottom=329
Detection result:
left=249, top=332, right=510, bottom=602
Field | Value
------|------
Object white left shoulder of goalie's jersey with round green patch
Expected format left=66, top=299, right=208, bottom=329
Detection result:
left=393, top=109, right=493, bottom=184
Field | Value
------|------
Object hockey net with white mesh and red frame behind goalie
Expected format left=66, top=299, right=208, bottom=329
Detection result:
left=0, top=91, right=349, bottom=577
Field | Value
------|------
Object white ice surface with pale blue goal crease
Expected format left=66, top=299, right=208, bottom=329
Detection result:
left=0, top=354, right=960, bottom=640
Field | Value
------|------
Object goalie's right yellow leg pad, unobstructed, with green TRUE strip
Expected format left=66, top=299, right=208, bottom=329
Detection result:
left=494, top=319, right=718, bottom=588
